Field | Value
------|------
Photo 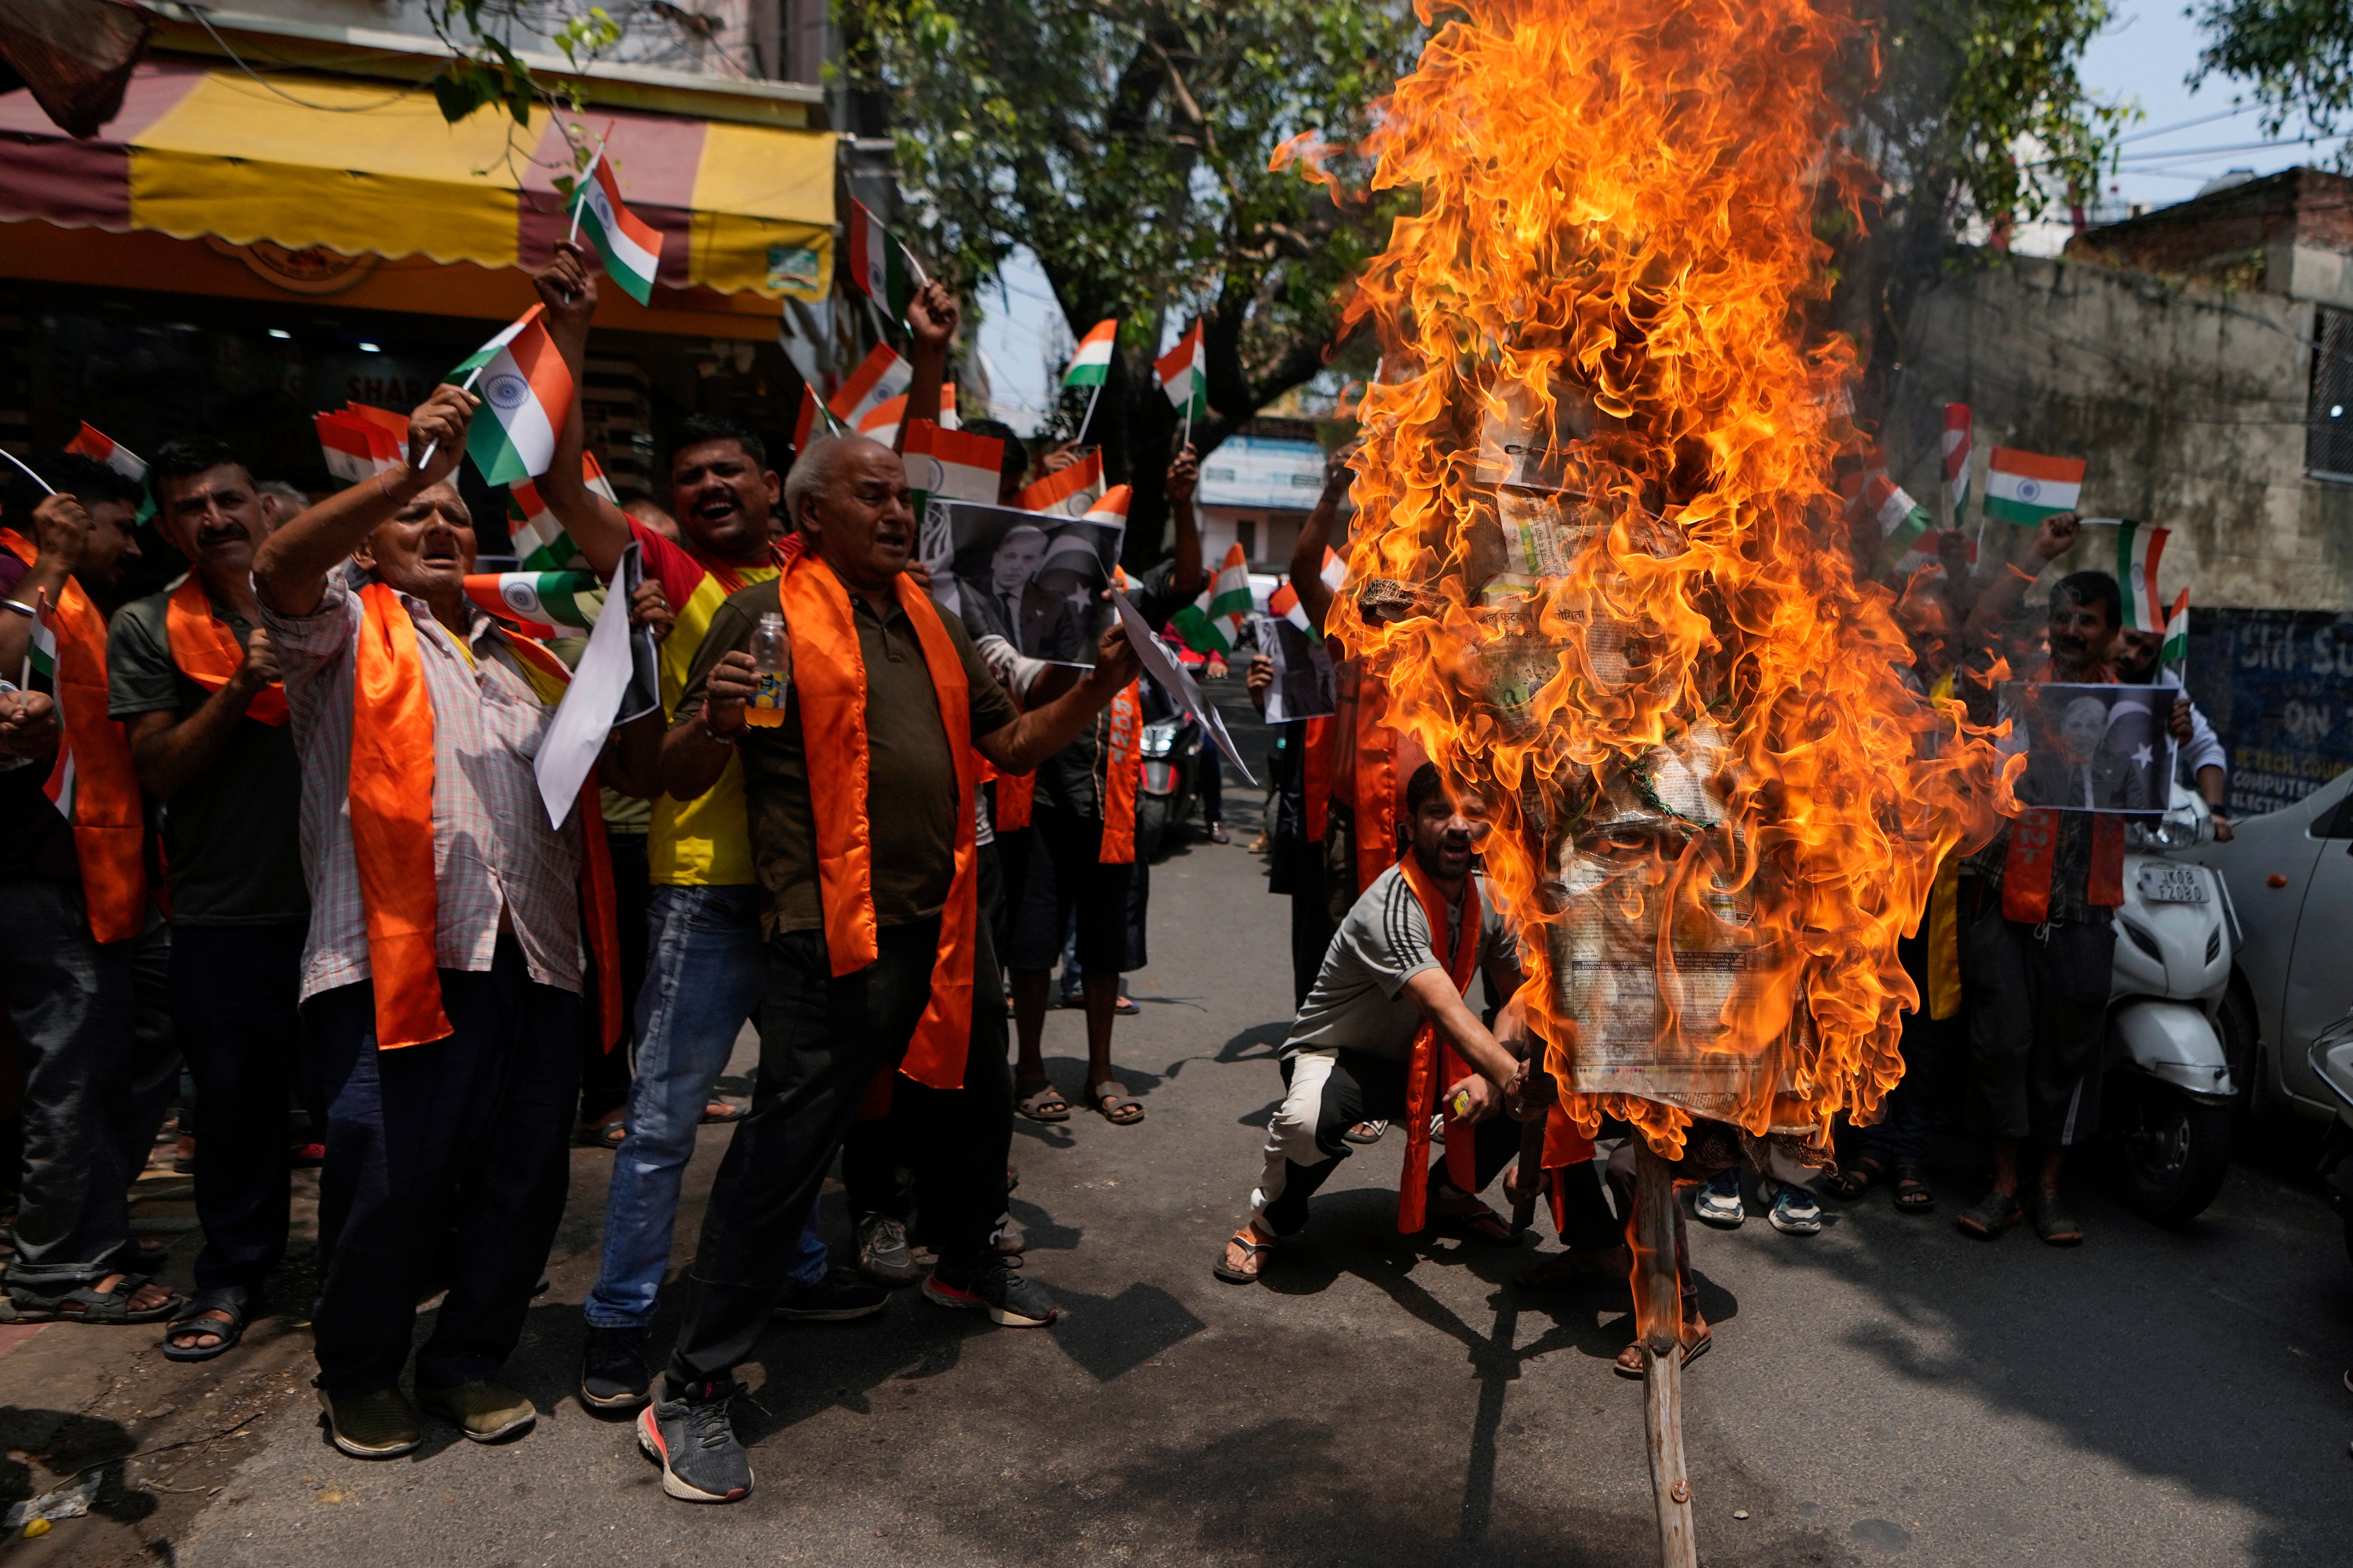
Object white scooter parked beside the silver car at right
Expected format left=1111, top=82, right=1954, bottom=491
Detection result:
left=2101, top=783, right=2240, bottom=1225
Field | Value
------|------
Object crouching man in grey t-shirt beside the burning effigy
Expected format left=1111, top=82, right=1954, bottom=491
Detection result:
left=1212, top=762, right=1539, bottom=1284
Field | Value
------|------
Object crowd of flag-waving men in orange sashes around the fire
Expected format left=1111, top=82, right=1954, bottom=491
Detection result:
left=0, top=247, right=2221, bottom=1502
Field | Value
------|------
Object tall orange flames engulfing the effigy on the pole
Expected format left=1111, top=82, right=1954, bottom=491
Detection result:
left=1318, top=0, right=1993, bottom=1156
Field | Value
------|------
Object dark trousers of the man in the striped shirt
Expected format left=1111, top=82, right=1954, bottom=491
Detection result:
left=304, top=938, right=581, bottom=1399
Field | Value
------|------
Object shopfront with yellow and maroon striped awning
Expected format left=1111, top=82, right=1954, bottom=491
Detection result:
left=0, top=54, right=838, bottom=576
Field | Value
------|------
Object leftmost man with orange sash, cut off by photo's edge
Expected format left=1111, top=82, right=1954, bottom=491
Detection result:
left=0, top=456, right=179, bottom=1324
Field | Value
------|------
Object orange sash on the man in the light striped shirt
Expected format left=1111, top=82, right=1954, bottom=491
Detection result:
left=351, top=583, right=621, bottom=1051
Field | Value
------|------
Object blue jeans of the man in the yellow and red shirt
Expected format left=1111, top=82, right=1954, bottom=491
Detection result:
left=586, top=886, right=826, bottom=1328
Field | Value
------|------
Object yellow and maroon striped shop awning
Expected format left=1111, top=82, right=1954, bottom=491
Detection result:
left=0, top=61, right=835, bottom=298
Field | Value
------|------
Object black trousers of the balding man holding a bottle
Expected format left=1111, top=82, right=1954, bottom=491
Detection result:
left=671, top=919, right=1014, bottom=1399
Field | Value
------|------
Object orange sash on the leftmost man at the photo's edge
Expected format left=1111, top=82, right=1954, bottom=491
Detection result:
left=0, top=529, right=148, bottom=943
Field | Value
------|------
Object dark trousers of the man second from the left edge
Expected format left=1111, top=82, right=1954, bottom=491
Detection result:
left=169, top=919, right=311, bottom=1293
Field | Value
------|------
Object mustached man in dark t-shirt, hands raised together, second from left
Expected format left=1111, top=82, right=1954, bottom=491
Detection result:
left=106, top=440, right=311, bottom=1361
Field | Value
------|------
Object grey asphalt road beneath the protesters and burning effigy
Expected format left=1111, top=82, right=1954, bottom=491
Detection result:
left=14, top=691, right=2353, bottom=1568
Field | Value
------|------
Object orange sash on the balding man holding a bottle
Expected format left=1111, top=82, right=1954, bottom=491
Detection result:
left=777, top=555, right=979, bottom=1088
